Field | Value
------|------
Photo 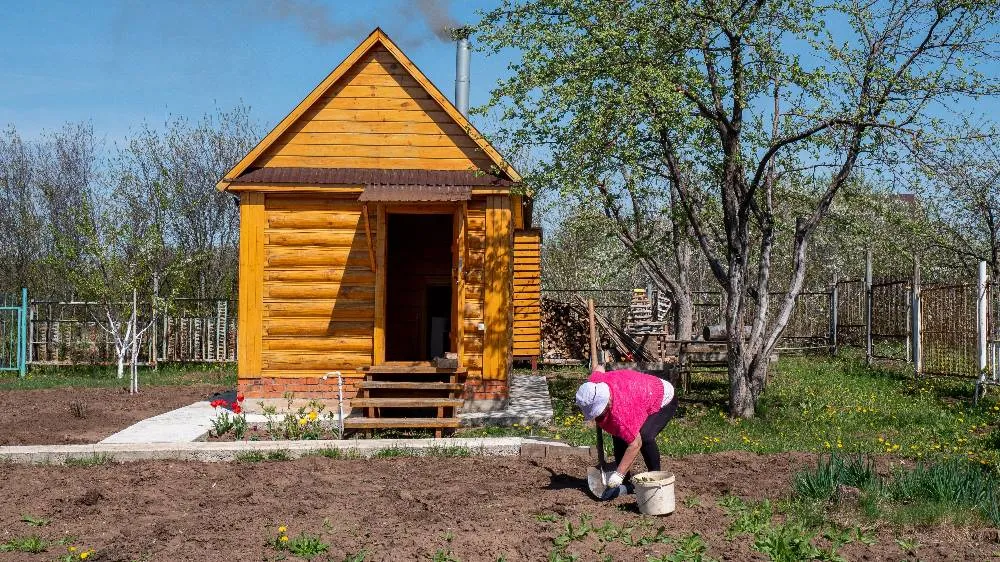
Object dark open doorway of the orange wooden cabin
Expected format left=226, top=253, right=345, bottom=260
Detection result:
left=385, top=214, right=453, bottom=361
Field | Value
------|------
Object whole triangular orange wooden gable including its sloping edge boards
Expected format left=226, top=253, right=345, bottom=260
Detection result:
left=219, top=29, right=520, bottom=189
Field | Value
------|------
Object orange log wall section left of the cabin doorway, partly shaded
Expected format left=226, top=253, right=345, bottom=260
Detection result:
left=261, top=194, right=377, bottom=378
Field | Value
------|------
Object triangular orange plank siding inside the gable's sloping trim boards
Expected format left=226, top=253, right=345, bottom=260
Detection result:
left=257, top=45, right=493, bottom=170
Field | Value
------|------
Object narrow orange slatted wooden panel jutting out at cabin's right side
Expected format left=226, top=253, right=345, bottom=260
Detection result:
left=513, top=229, right=542, bottom=357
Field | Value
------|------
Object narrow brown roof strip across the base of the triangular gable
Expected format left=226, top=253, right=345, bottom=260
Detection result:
left=230, top=168, right=514, bottom=188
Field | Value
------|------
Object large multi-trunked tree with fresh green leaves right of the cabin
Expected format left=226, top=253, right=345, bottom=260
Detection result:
left=478, top=0, right=998, bottom=418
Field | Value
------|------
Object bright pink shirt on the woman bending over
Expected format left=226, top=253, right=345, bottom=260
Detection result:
left=590, top=369, right=666, bottom=443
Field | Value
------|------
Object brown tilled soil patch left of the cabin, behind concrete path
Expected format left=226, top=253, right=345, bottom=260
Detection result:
left=0, top=384, right=222, bottom=445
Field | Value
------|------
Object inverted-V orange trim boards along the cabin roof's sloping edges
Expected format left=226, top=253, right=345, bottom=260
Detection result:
left=217, top=28, right=521, bottom=189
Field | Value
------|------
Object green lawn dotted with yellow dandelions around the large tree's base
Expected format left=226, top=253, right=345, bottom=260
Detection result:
left=459, top=356, right=1000, bottom=466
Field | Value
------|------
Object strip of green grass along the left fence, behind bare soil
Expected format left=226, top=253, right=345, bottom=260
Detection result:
left=0, top=363, right=236, bottom=390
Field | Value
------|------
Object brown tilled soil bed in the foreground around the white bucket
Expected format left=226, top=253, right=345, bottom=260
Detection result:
left=0, top=452, right=998, bottom=562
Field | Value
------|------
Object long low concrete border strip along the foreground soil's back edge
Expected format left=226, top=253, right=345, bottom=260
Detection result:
left=0, top=437, right=596, bottom=464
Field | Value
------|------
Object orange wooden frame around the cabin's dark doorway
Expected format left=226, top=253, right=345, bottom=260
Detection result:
left=372, top=201, right=468, bottom=366
